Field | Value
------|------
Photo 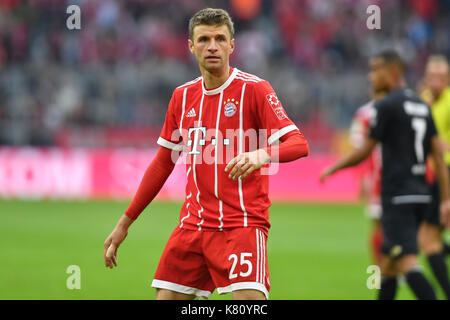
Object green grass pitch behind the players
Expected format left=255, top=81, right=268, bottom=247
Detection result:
left=0, top=201, right=443, bottom=300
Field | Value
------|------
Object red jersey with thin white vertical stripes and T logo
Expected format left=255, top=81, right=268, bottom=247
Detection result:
left=158, top=68, right=298, bottom=232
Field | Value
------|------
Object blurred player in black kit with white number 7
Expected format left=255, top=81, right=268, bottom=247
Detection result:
left=321, top=51, right=450, bottom=299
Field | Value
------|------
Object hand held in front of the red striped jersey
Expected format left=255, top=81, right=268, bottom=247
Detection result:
left=225, top=149, right=270, bottom=180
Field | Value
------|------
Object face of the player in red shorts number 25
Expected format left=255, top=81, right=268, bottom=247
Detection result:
left=189, top=25, right=234, bottom=72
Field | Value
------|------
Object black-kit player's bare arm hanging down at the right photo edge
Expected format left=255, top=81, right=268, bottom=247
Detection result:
left=431, top=135, right=450, bottom=228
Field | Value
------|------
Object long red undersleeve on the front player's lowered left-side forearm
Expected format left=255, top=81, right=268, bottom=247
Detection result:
left=125, top=147, right=175, bottom=220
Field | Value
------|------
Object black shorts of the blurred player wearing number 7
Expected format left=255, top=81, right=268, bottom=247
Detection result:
left=381, top=200, right=430, bottom=259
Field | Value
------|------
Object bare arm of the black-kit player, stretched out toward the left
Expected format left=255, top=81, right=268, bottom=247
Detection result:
left=320, top=137, right=378, bottom=182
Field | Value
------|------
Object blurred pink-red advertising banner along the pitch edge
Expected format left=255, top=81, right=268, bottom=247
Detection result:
left=0, top=148, right=359, bottom=202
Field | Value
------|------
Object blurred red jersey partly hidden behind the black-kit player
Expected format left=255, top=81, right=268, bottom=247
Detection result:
left=350, top=100, right=381, bottom=205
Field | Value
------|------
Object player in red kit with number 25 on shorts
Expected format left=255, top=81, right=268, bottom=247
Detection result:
left=104, top=8, right=308, bottom=299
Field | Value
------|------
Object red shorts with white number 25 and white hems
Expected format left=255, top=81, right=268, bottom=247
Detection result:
left=152, top=227, right=270, bottom=299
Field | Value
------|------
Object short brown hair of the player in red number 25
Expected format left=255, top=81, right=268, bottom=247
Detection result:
left=189, top=8, right=234, bottom=40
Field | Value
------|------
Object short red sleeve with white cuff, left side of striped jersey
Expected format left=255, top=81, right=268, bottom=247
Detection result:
left=157, top=92, right=183, bottom=151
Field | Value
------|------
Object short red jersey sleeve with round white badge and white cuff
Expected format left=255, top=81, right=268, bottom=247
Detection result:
left=253, top=81, right=299, bottom=145
